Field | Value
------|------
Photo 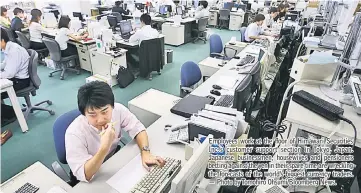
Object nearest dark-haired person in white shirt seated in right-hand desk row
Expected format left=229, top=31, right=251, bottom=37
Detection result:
left=244, top=14, right=271, bottom=42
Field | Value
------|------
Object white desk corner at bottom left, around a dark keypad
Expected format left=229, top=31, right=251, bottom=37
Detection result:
left=1, top=162, right=72, bottom=193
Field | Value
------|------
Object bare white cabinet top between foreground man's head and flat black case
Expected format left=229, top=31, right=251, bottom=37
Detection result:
left=128, top=88, right=181, bottom=127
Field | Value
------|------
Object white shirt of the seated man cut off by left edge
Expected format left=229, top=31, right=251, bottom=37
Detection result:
left=0, top=41, right=30, bottom=79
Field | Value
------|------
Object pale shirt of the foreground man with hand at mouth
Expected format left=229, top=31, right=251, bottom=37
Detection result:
left=65, top=103, right=145, bottom=182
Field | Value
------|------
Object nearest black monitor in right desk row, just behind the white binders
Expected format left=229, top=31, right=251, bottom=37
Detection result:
left=233, top=74, right=252, bottom=114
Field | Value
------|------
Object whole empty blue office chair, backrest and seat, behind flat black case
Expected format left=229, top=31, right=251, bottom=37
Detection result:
left=180, top=61, right=202, bottom=98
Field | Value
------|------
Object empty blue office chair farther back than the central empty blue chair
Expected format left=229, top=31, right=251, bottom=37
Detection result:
left=209, top=34, right=237, bottom=60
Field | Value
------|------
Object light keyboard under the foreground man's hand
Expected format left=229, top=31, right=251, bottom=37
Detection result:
left=130, top=158, right=181, bottom=193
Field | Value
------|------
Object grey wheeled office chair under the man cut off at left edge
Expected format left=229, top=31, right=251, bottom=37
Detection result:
left=16, top=49, right=55, bottom=119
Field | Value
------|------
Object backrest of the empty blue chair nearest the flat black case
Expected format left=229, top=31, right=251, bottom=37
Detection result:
left=181, top=61, right=202, bottom=87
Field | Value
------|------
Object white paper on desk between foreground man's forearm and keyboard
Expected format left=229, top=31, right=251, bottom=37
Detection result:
left=107, top=154, right=148, bottom=192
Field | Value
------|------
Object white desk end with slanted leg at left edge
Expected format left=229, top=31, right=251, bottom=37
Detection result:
left=0, top=79, right=29, bottom=132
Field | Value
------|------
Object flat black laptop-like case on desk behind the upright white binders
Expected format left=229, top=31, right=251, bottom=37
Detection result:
left=170, top=94, right=212, bottom=118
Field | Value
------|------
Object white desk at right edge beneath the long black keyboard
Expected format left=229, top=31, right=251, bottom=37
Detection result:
left=285, top=84, right=361, bottom=147
